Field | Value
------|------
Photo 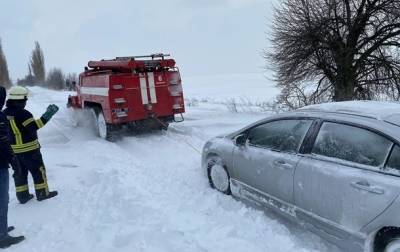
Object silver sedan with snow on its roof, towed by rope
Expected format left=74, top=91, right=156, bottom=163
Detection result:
left=202, top=102, right=400, bottom=252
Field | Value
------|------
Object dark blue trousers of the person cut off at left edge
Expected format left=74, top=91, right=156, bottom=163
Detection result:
left=0, top=168, right=9, bottom=240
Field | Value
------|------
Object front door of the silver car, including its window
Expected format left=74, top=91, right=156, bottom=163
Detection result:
left=233, top=119, right=312, bottom=203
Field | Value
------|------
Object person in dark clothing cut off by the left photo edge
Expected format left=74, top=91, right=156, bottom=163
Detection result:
left=0, top=86, right=25, bottom=248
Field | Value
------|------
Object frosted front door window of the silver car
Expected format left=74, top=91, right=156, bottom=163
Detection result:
left=248, top=120, right=312, bottom=152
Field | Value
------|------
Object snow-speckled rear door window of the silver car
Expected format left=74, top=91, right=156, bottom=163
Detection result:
left=312, top=122, right=392, bottom=167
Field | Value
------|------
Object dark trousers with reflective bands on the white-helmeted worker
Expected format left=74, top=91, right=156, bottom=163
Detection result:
left=13, top=149, right=49, bottom=201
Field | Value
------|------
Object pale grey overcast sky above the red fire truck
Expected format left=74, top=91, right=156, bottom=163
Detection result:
left=0, top=0, right=274, bottom=80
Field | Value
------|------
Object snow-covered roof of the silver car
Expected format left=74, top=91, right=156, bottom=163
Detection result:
left=297, top=101, right=400, bottom=126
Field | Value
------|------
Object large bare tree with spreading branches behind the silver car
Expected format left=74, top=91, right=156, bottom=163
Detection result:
left=265, top=0, right=400, bottom=107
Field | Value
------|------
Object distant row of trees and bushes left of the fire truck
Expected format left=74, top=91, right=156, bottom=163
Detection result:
left=0, top=41, right=78, bottom=90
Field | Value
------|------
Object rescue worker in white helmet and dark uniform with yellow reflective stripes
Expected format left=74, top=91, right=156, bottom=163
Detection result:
left=4, top=86, right=58, bottom=204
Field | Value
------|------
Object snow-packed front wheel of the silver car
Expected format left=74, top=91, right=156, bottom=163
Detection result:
left=207, top=157, right=231, bottom=194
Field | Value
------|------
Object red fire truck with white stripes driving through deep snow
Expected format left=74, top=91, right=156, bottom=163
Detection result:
left=68, top=54, right=185, bottom=140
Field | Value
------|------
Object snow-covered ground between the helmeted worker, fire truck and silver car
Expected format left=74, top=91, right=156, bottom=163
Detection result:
left=9, top=75, right=338, bottom=252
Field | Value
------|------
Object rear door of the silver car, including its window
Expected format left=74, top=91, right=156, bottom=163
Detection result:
left=294, top=122, right=399, bottom=235
